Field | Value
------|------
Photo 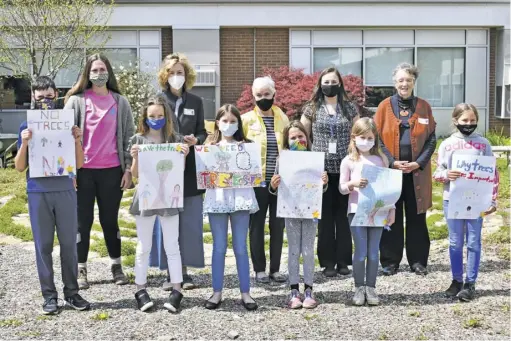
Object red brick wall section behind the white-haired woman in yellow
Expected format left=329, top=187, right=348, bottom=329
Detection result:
left=220, top=28, right=289, bottom=104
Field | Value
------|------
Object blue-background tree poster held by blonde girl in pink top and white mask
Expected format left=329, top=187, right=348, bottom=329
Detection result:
left=351, top=164, right=403, bottom=226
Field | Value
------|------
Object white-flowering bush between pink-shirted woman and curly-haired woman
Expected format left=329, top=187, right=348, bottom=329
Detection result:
left=113, top=62, right=156, bottom=126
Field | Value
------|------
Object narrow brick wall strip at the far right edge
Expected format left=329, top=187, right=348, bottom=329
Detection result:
left=488, top=28, right=510, bottom=136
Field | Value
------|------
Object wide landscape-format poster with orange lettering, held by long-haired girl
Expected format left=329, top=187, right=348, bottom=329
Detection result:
left=195, top=143, right=265, bottom=189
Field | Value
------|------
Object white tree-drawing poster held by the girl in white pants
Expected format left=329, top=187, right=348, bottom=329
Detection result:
left=137, top=143, right=185, bottom=211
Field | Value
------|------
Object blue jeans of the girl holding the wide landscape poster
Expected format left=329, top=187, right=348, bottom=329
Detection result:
left=209, top=211, right=250, bottom=293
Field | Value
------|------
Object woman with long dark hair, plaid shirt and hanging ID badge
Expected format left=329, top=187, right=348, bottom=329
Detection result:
left=300, top=67, right=359, bottom=277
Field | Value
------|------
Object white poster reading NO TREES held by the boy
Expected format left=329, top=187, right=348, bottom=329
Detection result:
left=27, top=110, right=76, bottom=178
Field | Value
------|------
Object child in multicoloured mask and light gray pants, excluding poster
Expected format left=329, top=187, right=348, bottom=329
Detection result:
left=268, top=121, right=328, bottom=309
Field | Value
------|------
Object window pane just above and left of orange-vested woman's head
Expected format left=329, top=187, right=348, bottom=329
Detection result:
left=364, top=47, right=413, bottom=86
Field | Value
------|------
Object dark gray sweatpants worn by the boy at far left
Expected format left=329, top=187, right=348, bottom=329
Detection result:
left=28, top=190, right=78, bottom=299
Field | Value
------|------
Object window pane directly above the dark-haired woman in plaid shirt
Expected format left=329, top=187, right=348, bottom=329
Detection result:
left=314, top=47, right=362, bottom=77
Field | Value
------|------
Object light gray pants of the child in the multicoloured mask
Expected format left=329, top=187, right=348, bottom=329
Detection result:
left=286, top=218, right=317, bottom=286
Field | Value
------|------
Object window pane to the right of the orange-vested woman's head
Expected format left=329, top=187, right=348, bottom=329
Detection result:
left=417, top=47, right=465, bottom=107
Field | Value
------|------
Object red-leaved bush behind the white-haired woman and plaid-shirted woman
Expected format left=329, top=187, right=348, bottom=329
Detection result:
left=236, top=66, right=366, bottom=117
